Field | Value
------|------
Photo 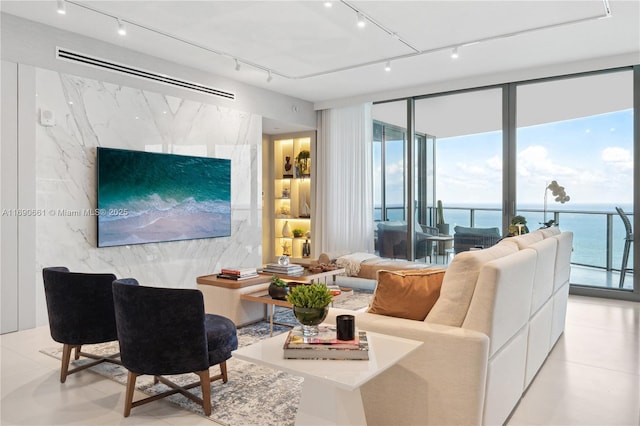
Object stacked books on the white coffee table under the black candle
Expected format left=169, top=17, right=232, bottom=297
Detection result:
left=283, top=326, right=369, bottom=360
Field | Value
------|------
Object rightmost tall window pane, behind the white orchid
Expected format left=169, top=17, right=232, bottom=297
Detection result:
left=516, top=70, right=634, bottom=289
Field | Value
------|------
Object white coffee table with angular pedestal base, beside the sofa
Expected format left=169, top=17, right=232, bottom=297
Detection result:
left=233, top=331, right=422, bottom=426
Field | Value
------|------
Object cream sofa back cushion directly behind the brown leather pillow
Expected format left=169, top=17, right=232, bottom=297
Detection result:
left=425, top=241, right=528, bottom=327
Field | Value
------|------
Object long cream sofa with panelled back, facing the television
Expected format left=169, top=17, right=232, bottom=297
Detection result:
left=327, top=228, right=573, bottom=425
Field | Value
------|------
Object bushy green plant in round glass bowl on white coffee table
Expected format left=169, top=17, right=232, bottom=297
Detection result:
left=287, top=283, right=333, bottom=336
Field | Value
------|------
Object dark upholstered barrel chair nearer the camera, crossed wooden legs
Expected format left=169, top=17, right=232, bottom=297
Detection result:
left=113, top=278, right=238, bottom=417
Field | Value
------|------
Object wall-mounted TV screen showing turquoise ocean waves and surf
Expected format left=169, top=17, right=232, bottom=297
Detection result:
left=98, top=148, right=231, bottom=247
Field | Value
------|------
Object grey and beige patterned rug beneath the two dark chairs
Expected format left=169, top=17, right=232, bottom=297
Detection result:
left=40, top=289, right=372, bottom=426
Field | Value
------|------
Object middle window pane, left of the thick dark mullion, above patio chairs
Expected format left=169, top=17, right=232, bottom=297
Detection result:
left=415, top=88, right=502, bottom=234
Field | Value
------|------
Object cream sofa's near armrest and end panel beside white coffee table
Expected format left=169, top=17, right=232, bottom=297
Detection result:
left=326, top=308, right=489, bottom=425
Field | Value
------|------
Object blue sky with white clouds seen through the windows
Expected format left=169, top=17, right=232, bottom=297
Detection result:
left=436, top=109, right=633, bottom=208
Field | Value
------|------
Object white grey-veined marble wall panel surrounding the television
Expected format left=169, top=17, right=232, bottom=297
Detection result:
left=34, top=69, right=262, bottom=322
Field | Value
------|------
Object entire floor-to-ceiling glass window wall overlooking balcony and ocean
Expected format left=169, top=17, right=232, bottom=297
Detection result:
left=374, top=66, right=640, bottom=300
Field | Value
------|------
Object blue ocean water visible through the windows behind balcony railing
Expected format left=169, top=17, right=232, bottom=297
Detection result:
left=374, top=203, right=633, bottom=269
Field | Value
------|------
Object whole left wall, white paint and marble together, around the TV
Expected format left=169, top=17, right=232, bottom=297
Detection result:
left=0, top=14, right=315, bottom=332
